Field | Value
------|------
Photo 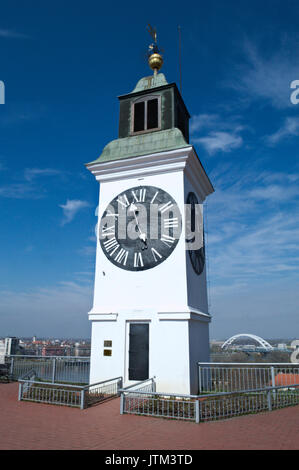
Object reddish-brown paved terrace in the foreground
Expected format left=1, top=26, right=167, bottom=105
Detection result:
left=0, top=383, right=299, bottom=450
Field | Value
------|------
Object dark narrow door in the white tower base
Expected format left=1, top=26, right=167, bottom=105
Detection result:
left=129, top=323, right=149, bottom=380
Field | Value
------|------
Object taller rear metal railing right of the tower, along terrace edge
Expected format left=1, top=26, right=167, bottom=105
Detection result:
left=198, top=362, right=299, bottom=394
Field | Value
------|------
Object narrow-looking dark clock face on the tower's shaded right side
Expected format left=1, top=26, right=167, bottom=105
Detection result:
left=186, top=193, right=205, bottom=275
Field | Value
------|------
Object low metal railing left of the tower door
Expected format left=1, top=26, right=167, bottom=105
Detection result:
left=18, top=376, right=122, bottom=410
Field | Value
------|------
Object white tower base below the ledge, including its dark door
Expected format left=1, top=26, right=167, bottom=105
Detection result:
left=89, top=309, right=210, bottom=395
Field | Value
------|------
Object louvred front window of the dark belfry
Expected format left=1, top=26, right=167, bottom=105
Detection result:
left=131, top=96, right=161, bottom=134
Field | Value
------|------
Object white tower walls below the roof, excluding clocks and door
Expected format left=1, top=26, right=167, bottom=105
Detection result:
left=89, top=147, right=214, bottom=394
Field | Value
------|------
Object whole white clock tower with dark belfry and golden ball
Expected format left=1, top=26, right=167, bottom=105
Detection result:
left=86, top=40, right=214, bottom=394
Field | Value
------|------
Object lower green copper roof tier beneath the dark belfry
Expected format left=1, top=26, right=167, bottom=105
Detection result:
left=89, top=127, right=190, bottom=164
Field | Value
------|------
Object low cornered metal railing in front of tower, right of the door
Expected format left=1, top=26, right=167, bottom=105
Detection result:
left=120, top=384, right=299, bottom=423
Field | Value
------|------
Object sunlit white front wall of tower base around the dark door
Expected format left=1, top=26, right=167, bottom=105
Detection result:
left=90, top=312, right=190, bottom=394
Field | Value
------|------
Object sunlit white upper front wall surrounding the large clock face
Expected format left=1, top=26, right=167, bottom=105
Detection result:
left=93, top=171, right=187, bottom=313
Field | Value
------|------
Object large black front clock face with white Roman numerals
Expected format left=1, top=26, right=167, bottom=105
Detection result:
left=99, top=186, right=182, bottom=271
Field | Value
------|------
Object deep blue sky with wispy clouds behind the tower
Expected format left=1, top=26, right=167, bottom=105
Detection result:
left=0, top=0, right=299, bottom=338
